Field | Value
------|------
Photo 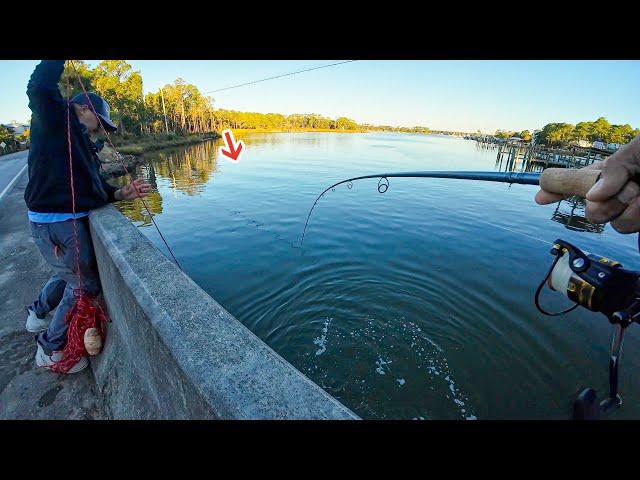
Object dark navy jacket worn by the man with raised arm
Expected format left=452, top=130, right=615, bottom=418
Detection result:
left=24, top=60, right=117, bottom=213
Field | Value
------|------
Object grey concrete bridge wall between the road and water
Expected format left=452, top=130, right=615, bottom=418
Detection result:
left=90, top=205, right=358, bottom=419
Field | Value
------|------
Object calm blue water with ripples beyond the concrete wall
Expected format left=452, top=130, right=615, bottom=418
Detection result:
left=114, top=133, right=640, bottom=419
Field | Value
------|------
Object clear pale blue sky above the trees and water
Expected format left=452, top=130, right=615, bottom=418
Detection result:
left=0, top=59, right=640, bottom=132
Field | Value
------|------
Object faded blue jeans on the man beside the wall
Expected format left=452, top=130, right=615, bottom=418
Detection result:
left=30, top=217, right=100, bottom=354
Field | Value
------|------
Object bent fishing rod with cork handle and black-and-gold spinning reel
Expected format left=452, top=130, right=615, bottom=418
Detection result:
left=300, top=168, right=640, bottom=420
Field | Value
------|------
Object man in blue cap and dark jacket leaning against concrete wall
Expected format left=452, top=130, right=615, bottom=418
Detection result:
left=24, top=60, right=151, bottom=373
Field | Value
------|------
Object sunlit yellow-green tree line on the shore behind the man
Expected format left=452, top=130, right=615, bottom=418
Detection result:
left=60, top=60, right=416, bottom=136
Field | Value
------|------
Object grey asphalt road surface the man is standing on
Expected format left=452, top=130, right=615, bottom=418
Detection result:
left=0, top=173, right=105, bottom=420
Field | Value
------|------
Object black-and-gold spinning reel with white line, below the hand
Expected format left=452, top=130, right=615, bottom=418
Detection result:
left=535, top=239, right=640, bottom=420
